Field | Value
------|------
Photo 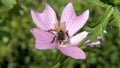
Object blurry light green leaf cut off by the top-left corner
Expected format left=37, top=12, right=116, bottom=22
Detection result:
left=1, top=0, right=17, bottom=9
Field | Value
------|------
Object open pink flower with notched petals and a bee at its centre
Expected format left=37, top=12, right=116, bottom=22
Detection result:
left=31, top=3, right=100, bottom=59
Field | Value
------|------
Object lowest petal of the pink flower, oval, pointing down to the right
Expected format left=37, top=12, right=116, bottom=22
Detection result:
left=58, top=46, right=86, bottom=59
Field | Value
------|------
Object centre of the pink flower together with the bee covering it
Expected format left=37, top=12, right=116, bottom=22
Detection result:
left=48, top=22, right=70, bottom=47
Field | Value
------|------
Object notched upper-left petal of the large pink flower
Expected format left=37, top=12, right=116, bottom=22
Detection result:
left=31, top=4, right=57, bottom=30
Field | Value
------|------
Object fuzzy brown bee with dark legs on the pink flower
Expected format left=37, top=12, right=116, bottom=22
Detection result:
left=49, top=22, right=69, bottom=45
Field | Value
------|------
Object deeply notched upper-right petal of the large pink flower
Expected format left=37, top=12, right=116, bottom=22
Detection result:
left=60, top=3, right=89, bottom=36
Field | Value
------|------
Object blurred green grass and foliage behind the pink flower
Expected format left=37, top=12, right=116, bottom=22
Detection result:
left=0, top=0, right=120, bottom=68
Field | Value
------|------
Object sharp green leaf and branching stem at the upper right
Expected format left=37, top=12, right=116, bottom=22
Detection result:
left=88, top=0, right=120, bottom=41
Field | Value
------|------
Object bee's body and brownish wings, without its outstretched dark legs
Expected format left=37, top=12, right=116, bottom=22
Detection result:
left=52, top=22, right=69, bottom=46
